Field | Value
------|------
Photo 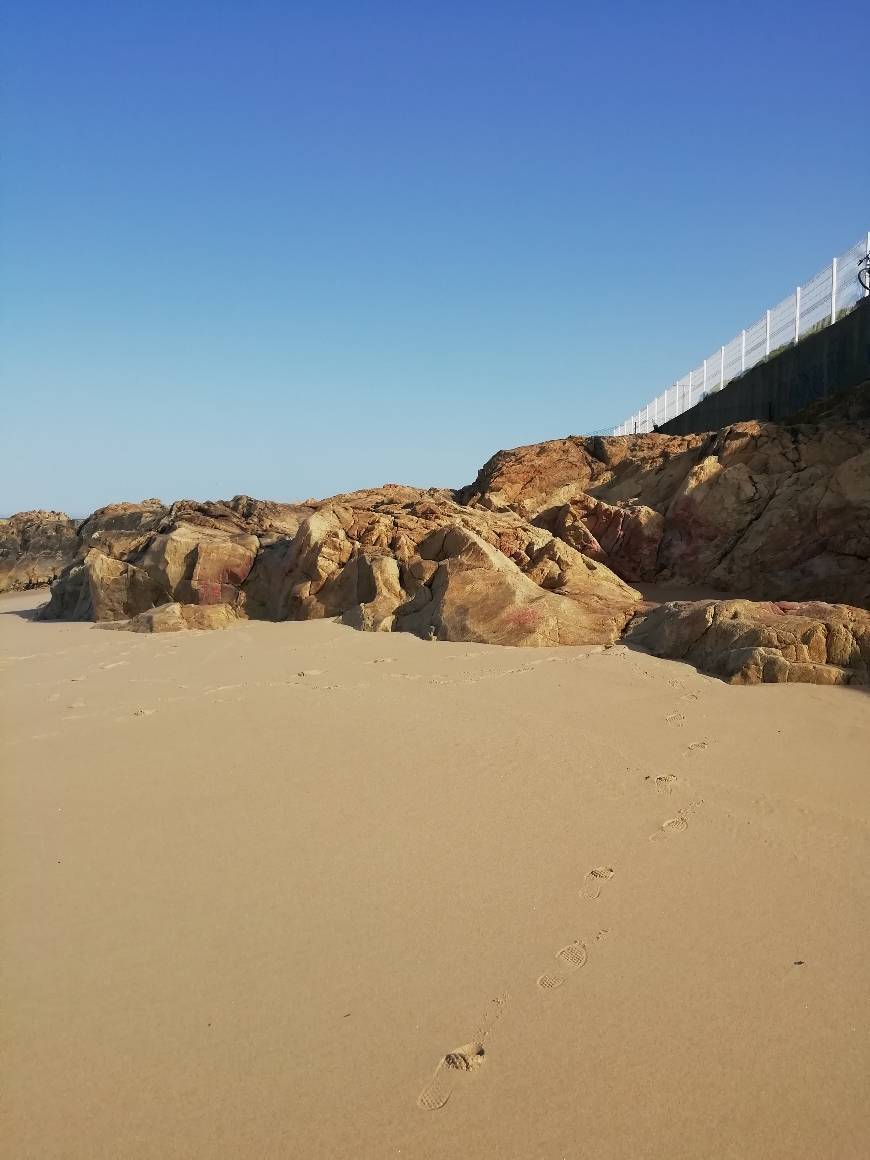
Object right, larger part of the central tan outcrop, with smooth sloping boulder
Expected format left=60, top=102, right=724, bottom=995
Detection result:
left=241, top=490, right=640, bottom=644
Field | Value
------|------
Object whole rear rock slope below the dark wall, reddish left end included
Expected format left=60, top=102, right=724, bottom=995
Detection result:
left=463, top=422, right=870, bottom=607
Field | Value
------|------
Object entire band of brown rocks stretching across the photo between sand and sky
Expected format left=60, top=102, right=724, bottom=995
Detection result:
left=8, top=406, right=870, bottom=683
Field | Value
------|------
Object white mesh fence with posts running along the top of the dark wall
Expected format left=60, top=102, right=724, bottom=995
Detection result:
left=608, top=233, right=870, bottom=435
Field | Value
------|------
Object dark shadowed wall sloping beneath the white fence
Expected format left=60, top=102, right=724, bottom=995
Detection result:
left=659, top=298, right=870, bottom=435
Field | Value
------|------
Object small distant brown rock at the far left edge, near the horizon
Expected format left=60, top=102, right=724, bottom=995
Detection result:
left=0, top=512, right=79, bottom=592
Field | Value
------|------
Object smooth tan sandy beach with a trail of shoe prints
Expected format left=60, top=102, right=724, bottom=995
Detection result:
left=0, top=592, right=870, bottom=1160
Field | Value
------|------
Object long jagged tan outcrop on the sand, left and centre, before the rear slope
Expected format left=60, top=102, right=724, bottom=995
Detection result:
left=34, top=486, right=640, bottom=644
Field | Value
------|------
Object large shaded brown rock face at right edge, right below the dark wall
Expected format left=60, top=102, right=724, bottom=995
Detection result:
left=659, top=422, right=870, bottom=608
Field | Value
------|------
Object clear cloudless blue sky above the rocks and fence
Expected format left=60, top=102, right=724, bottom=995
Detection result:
left=0, top=0, right=870, bottom=515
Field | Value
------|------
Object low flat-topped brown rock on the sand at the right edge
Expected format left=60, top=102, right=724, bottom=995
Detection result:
left=625, top=600, right=870, bottom=684
